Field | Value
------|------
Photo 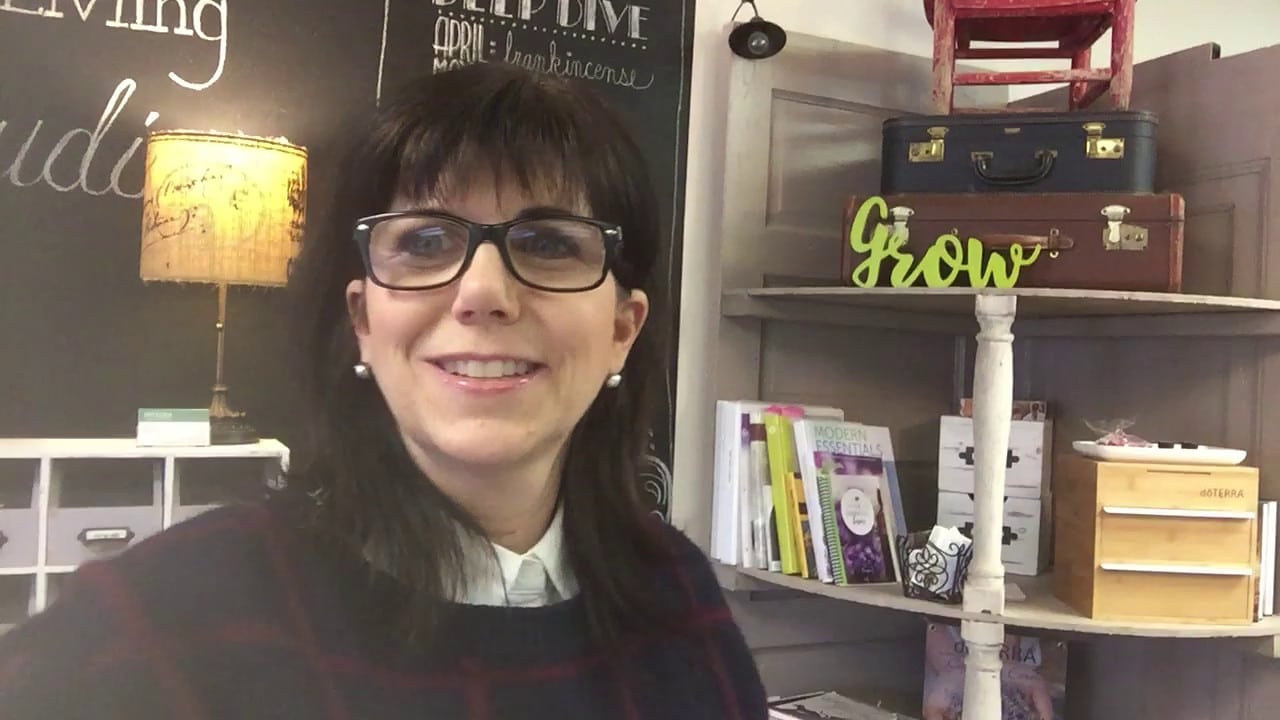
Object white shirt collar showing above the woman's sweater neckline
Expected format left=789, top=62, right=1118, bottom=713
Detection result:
left=457, top=506, right=577, bottom=607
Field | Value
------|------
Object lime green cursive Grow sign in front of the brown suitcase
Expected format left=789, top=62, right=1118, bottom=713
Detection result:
left=849, top=197, right=1041, bottom=287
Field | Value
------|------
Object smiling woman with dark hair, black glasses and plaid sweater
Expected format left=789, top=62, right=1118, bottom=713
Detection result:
left=0, top=64, right=765, bottom=720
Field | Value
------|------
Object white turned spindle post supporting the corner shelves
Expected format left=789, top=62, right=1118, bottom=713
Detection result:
left=960, top=295, right=1018, bottom=720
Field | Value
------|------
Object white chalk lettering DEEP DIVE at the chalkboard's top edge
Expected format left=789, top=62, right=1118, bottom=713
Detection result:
left=431, top=0, right=649, bottom=40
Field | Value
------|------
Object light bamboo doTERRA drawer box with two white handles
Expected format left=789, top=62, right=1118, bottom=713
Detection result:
left=1053, top=452, right=1258, bottom=624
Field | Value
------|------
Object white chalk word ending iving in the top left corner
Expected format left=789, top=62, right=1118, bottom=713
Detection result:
left=0, top=0, right=227, bottom=90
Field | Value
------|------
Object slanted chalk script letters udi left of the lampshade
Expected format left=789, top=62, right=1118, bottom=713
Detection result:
left=0, top=78, right=160, bottom=197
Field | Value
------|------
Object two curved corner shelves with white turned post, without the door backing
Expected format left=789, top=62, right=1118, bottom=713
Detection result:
left=721, top=287, right=1280, bottom=720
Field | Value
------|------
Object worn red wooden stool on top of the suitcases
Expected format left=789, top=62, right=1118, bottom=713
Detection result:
left=924, top=0, right=1137, bottom=114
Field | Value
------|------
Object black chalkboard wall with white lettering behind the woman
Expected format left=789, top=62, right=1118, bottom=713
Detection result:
left=0, top=0, right=692, bottom=515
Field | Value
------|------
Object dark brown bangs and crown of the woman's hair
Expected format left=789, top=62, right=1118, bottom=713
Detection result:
left=342, top=63, right=663, bottom=288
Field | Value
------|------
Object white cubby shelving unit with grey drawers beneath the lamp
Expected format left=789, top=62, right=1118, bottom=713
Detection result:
left=0, top=438, right=289, bottom=625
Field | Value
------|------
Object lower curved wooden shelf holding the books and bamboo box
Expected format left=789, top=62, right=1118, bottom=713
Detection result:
left=717, top=564, right=1280, bottom=638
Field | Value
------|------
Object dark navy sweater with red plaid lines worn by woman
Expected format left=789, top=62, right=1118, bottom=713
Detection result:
left=0, top=502, right=767, bottom=720
